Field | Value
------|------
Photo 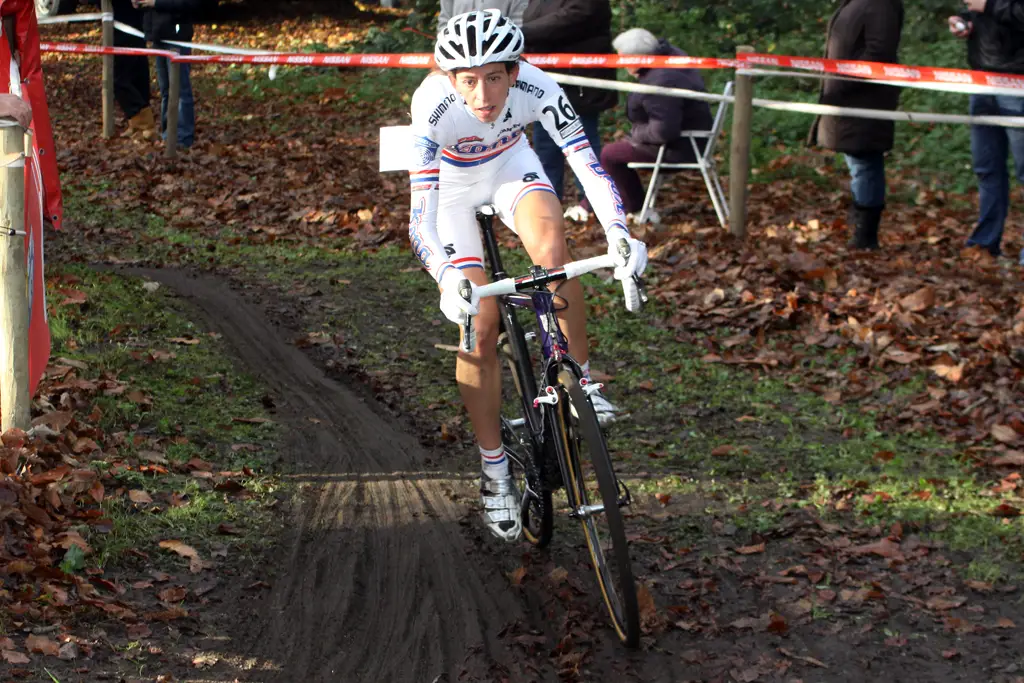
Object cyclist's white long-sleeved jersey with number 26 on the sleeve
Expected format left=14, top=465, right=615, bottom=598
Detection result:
left=409, top=62, right=628, bottom=282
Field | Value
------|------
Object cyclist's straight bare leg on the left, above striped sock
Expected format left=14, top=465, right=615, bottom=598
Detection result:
left=455, top=268, right=502, bottom=451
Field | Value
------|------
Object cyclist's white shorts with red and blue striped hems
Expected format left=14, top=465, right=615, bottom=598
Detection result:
left=437, top=140, right=555, bottom=270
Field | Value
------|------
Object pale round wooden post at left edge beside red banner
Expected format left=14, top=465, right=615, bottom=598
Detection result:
left=0, top=120, right=32, bottom=431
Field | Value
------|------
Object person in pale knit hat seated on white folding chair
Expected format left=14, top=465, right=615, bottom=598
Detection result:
left=601, top=29, right=713, bottom=222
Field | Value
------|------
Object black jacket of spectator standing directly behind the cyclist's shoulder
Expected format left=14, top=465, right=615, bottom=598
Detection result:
left=522, top=0, right=618, bottom=115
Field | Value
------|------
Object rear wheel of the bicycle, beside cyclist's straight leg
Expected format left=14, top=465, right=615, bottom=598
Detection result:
left=498, top=302, right=554, bottom=548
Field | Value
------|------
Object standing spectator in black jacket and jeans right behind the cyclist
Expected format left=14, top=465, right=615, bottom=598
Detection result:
left=521, top=0, right=618, bottom=221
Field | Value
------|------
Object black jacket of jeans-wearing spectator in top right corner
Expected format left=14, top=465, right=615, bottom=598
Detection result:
left=963, top=0, right=1024, bottom=74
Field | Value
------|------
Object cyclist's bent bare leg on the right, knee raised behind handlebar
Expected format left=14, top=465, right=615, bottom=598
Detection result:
left=514, top=191, right=590, bottom=365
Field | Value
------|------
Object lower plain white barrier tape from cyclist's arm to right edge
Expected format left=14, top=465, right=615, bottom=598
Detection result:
left=548, top=72, right=1024, bottom=128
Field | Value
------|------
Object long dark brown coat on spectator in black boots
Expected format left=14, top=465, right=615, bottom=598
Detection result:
left=810, top=0, right=903, bottom=155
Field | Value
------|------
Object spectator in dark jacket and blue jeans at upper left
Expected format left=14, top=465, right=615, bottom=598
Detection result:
left=132, top=0, right=202, bottom=147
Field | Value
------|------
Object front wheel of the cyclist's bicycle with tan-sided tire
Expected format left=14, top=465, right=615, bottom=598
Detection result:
left=553, top=366, right=640, bottom=647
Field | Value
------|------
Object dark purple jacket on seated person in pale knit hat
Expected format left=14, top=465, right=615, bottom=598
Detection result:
left=626, top=40, right=713, bottom=163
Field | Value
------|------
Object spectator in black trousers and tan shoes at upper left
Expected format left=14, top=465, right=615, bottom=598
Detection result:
left=114, top=0, right=157, bottom=135
